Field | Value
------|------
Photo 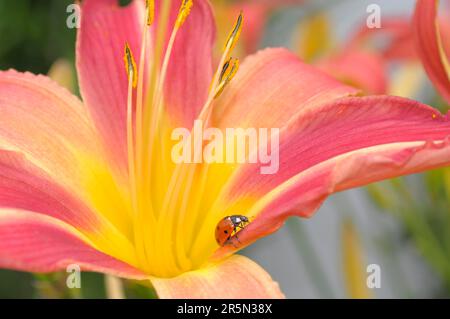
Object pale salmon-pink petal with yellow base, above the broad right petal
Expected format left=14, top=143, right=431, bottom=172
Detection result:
left=188, top=49, right=359, bottom=259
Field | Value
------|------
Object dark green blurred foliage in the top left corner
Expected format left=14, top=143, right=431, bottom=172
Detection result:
left=0, top=0, right=76, bottom=74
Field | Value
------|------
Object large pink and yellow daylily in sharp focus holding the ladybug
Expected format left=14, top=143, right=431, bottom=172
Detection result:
left=0, top=0, right=450, bottom=298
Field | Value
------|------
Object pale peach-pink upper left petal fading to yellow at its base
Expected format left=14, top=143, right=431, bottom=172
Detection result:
left=0, top=71, right=131, bottom=249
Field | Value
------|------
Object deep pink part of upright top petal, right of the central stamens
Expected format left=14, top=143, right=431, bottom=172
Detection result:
left=159, top=0, right=216, bottom=127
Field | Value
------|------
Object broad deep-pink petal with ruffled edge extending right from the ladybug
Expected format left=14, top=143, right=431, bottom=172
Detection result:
left=214, top=96, right=450, bottom=255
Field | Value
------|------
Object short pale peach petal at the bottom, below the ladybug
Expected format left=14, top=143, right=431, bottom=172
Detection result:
left=151, top=255, right=284, bottom=299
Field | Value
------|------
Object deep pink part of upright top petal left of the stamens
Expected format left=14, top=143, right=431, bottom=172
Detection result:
left=76, top=0, right=145, bottom=169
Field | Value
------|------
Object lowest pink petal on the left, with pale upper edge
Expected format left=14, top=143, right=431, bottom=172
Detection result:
left=0, top=210, right=146, bottom=279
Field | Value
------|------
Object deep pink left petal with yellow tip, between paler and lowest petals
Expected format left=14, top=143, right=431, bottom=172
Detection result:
left=0, top=150, right=136, bottom=265
